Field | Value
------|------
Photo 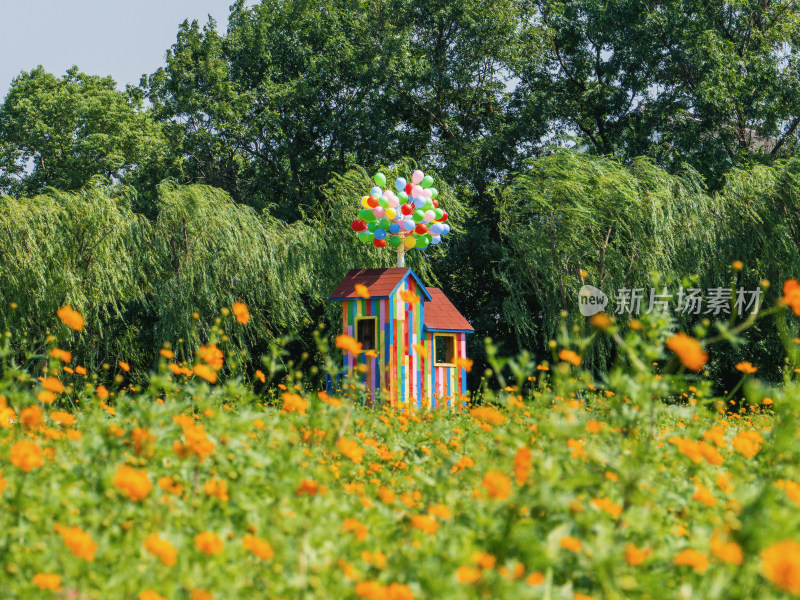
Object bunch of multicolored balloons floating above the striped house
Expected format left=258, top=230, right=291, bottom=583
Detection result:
left=351, top=170, right=450, bottom=261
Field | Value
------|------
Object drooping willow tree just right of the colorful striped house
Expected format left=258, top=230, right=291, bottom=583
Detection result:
left=498, top=151, right=715, bottom=364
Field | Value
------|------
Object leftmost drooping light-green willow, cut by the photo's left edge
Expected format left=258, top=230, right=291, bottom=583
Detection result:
left=0, top=185, right=153, bottom=364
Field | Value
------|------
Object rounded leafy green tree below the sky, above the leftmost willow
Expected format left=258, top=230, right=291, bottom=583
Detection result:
left=0, top=66, right=180, bottom=209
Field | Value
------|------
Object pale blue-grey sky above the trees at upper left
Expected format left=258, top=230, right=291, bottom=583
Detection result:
left=0, top=0, right=250, bottom=98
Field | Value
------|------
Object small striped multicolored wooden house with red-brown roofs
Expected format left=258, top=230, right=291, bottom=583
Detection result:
left=330, top=267, right=474, bottom=408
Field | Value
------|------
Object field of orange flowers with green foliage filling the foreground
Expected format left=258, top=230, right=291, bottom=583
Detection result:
left=0, top=298, right=800, bottom=600
